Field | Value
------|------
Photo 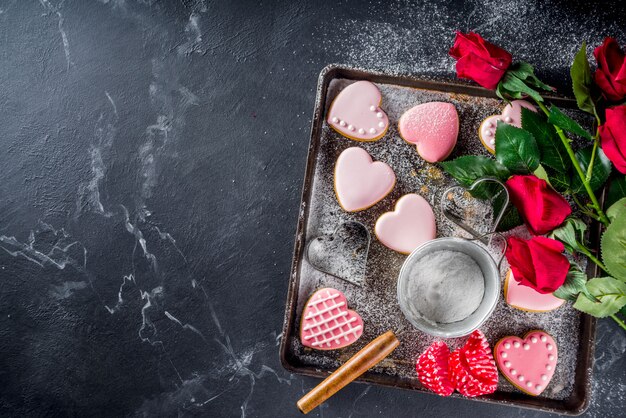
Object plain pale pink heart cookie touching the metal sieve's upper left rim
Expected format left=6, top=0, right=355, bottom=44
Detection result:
left=374, top=193, right=437, bottom=254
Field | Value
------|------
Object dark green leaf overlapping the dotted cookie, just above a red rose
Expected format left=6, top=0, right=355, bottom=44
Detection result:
left=496, top=121, right=539, bottom=174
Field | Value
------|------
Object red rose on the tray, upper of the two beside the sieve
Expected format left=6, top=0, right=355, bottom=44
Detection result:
left=506, top=175, right=572, bottom=235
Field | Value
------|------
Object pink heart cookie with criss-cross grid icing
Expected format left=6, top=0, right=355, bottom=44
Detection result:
left=300, top=287, right=363, bottom=350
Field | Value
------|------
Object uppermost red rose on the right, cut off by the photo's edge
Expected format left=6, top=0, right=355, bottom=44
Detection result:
left=593, top=38, right=626, bottom=102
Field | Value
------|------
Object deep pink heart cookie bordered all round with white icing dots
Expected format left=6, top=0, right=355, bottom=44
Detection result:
left=493, top=330, right=558, bottom=396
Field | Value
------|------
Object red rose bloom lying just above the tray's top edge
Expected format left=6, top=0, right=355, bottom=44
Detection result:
left=450, top=32, right=513, bottom=90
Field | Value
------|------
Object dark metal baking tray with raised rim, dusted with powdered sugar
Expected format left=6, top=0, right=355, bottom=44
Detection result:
left=280, top=65, right=599, bottom=415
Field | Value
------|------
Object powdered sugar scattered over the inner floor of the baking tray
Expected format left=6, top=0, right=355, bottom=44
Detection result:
left=287, top=79, right=581, bottom=401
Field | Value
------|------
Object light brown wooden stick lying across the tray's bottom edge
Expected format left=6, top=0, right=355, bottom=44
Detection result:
left=297, top=331, right=400, bottom=414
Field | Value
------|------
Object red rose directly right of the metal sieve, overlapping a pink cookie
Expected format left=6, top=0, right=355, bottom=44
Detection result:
left=506, top=237, right=569, bottom=293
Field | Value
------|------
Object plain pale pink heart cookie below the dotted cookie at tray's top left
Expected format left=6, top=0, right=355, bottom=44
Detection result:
left=335, top=147, right=396, bottom=212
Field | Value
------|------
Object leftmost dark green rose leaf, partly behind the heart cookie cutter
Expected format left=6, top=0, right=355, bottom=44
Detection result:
left=441, top=155, right=511, bottom=199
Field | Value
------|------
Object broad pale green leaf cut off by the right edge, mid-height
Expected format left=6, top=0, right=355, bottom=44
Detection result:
left=601, top=208, right=626, bottom=282
